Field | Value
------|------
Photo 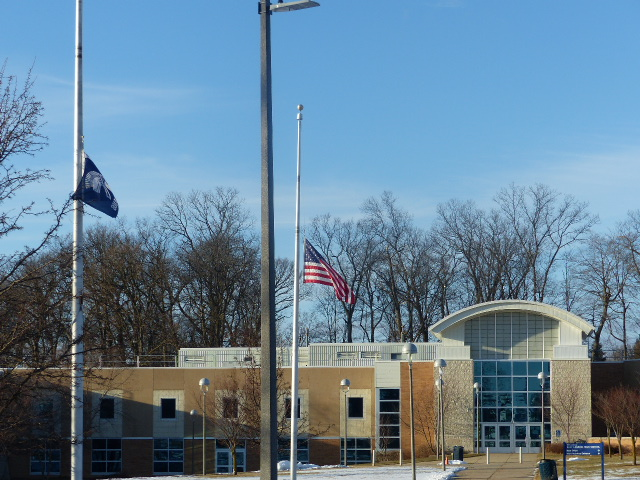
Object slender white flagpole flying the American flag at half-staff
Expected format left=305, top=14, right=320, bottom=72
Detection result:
left=289, top=105, right=304, bottom=480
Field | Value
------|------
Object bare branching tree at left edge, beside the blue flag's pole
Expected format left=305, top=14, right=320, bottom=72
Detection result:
left=0, top=62, right=70, bottom=454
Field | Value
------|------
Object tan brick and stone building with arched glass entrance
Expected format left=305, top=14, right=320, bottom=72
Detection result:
left=9, top=300, right=604, bottom=478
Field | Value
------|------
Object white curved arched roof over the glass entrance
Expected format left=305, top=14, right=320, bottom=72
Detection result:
left=429, top=300, right=593, bottom=340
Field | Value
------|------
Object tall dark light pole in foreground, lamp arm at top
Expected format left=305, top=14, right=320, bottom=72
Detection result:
left=259, top=0, right=319, bottom=480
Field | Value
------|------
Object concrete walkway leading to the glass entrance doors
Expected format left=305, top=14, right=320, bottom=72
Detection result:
left=454, top=453, right=539, bottom=480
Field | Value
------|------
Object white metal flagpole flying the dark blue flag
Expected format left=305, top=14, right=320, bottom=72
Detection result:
left=71, top=0, right=84, bottom=480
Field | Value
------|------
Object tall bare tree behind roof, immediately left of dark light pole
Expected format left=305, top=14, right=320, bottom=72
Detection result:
left=157, top=188, right=259, bottom=347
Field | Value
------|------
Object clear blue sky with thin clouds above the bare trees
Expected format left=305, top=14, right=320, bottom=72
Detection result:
left=0, top=0, right=640, bottom=258
